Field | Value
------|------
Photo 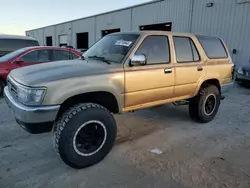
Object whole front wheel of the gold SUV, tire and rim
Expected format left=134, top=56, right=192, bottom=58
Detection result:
left=52, top=103, right=117, bottom=169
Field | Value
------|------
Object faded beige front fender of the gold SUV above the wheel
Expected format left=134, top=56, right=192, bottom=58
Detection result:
left=43, top=71, right=124, bottom=110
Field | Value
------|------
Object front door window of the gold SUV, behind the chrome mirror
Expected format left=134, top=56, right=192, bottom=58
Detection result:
left=136, top=36, right=170, bottom=64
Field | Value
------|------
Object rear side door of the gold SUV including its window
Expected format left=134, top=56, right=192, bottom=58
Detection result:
left=173, top=36, right=205, bottom=98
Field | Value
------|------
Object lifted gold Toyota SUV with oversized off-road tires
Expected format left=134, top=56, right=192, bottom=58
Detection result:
left=4, top=31, right=233, bottom=168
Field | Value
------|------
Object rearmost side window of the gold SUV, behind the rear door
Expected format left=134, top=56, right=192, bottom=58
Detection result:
left=197, top=36, right=228, bottom=59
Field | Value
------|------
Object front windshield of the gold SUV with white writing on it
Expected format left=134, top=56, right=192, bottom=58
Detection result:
left=84, top=34, right=140, bottom=63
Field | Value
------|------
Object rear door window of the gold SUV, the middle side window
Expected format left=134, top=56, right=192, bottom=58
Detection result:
left=174, top=37, right=200, bottom=63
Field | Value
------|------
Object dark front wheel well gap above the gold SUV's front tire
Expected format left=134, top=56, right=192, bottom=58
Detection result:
left=57, top=91, right=119, bottom=117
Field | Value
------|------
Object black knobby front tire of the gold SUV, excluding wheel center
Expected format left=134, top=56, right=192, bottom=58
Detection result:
left=52, top=103, right=117, bottom=169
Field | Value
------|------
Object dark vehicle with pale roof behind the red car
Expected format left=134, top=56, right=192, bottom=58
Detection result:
left=0, top=34, right=39, bottom=57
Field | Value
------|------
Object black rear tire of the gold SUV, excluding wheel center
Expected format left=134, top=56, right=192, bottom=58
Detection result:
left=189, top=85, right=221, bottom=123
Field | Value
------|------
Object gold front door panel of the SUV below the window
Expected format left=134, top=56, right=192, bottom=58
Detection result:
left=125, top=64, right=174, bottom=108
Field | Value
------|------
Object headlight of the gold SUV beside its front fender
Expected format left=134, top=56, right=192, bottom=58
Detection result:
left=17, top=86, right=46, bottom=105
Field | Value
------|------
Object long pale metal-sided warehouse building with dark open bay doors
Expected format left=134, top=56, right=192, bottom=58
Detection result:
left=26, top=0, right=250, bottom=64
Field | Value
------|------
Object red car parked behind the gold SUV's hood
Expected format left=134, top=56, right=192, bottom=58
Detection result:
left=0, top=46, right=82, bottom=96
